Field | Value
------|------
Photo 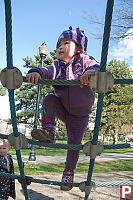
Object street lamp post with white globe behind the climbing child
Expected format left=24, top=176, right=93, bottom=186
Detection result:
left=28, top=43, right=48, bottom=161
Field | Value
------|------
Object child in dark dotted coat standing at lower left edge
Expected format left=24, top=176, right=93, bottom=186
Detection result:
left=0, top=139, right=16, bottom=200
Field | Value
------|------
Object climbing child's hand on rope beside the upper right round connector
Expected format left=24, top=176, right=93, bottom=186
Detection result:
left=80, top=70, right=94, bottom=88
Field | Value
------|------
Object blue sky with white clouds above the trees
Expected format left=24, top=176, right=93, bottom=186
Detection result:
left=0, top=0, right=133, bottom=118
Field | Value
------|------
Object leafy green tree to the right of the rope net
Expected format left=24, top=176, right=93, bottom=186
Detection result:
left=101, top=60, right=133, bottom=143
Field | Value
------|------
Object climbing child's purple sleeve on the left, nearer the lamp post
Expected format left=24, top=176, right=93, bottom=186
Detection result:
left=28, top=62, right=56, bottom=79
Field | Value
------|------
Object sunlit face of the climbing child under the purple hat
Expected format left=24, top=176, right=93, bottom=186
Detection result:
left=56, top=39, right=76, bottom=63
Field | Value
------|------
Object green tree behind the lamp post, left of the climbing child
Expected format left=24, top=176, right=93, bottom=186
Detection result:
left=15, top=51, right=56, bottom=124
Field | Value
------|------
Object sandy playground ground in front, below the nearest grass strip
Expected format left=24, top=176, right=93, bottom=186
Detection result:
left=9, top=172, right=133, bottom=200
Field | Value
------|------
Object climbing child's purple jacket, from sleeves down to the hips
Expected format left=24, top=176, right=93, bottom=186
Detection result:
left=28, top=54, right=100, bottom=116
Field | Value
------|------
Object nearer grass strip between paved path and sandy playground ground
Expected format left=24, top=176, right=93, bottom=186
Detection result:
left=14, top=159, right=133, bottom=175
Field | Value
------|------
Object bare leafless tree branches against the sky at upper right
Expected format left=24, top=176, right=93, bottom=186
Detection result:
left=83, top=0, right=133, bottom=39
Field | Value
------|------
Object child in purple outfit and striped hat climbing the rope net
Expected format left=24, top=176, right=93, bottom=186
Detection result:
left=26, top=27, right=99, bottom=191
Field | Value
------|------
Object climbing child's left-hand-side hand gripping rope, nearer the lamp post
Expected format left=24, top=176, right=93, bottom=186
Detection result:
left=26, top=72, right=41, bottom=84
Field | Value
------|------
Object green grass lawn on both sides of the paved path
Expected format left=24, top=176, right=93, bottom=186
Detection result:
left=9, top=141, right=133, bottom=175
